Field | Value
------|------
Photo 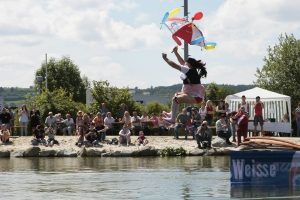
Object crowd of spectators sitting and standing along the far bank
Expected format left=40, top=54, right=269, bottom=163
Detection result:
left=0, top=96, right=300, bottom=148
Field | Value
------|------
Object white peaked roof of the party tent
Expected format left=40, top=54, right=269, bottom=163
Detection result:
left=226, top=87, right=290, bottom=100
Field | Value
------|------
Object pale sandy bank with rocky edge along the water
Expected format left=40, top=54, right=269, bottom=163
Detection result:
left=0, top=136, right=241, bottom=157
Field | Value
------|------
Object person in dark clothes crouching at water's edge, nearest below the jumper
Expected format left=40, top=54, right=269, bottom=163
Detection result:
left=195, top=121, right=212, bottom=149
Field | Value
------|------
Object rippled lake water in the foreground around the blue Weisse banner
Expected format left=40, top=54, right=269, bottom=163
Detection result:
left=0, top=156, right=300, bottom=199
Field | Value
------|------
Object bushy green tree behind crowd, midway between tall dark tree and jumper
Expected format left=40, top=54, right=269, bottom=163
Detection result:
left=91, top=81, right=143, bottom=118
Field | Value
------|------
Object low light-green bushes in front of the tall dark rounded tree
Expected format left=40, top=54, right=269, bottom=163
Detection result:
left=26, top=88, right=87, bottom=123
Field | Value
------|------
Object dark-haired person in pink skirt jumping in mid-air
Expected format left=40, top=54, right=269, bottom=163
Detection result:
left=162, top=46, right=207, bottom=124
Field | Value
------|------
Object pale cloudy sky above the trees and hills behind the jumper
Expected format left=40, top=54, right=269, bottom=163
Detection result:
left=0, top=0, right=300, bottom=89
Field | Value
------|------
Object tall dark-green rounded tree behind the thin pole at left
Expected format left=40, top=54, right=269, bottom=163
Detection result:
left=34, top=56, right=89, bottom=103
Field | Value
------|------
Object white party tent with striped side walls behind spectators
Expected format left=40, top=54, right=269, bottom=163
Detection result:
left=225, top=87, right=291, bottom=123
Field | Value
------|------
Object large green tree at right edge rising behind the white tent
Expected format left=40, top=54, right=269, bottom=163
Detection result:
left=254, top=34, right=300, bottom=108
